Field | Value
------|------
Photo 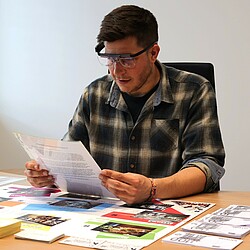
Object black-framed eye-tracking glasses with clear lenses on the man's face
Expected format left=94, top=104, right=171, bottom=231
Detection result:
left=95, top=42, right=156, bottom=69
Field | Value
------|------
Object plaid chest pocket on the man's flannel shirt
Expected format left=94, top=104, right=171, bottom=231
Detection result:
left=150, top=119, right=179, bottom=152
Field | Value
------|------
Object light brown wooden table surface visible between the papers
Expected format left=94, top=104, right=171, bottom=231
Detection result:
left=0, top=169, right=250, bottom=250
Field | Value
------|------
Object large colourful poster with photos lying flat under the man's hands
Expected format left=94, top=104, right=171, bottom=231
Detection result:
left=0, top=184, right=215, bottom=249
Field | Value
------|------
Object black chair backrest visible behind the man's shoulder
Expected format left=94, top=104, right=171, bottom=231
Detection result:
left=163, top=62, right=215, bottom=91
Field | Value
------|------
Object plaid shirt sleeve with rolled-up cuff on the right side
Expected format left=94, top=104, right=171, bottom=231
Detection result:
left=181, top=79, right=225, bottom=192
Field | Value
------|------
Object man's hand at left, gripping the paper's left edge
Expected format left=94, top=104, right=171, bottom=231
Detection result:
left=24, top=160, right=55, bottom=188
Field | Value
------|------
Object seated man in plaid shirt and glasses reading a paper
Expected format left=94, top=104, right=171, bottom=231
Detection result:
left=25, top=5, right=225, bottom=204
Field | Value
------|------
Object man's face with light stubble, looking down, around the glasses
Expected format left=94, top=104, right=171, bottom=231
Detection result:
left=105, top=37, right=160, bottom=96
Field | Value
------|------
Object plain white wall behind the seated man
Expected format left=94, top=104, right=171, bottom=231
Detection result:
left=0, top=0, right=250, bottom=190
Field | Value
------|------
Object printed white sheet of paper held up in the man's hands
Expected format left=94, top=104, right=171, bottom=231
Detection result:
left=14, top=133, right=114, bottom=198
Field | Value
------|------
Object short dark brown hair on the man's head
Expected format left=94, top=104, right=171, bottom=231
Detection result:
left=97, top=5, right=158, bottom=47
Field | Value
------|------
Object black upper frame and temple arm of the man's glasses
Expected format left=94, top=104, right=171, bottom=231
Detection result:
left=95, top=42, right=157, bottom=67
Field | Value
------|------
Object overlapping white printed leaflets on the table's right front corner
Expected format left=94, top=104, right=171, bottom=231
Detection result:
left=163, top=205, right=250, bottom=249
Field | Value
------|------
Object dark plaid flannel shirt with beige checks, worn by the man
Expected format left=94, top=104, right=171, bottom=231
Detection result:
left=63, top=61, right=225, bottom=192
